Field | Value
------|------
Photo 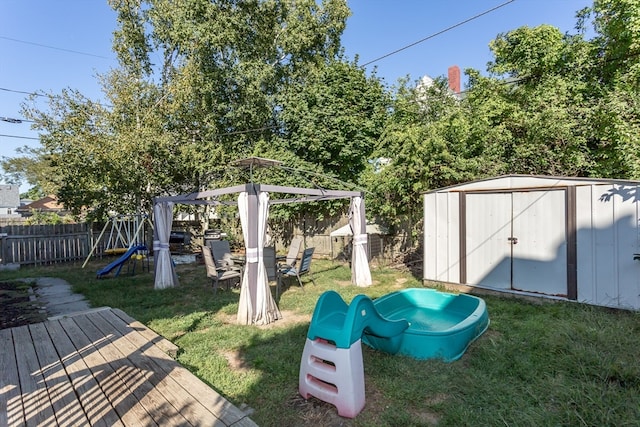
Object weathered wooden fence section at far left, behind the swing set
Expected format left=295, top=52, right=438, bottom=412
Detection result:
left=0, top=224, right=96, bottom=265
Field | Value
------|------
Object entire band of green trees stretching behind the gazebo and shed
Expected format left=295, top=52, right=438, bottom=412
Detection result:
left=10, top=0, right=640, bottom=231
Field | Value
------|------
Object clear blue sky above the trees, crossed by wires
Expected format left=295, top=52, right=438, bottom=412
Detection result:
left=0, top=0, right=592, bottom=191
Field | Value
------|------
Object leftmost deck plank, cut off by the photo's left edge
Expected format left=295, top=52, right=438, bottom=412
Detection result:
left=0, top=329, right=24, bottom=426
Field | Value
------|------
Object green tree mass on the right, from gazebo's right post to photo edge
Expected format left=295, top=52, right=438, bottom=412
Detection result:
left=367, top=0, right=640, bottom=226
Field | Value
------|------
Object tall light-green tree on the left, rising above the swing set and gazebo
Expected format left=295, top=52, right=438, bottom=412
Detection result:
left=18, top=0, right=356, bottom=217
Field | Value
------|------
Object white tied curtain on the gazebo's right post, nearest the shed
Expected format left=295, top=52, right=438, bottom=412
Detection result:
left=349, top=197, right=371, bottom=286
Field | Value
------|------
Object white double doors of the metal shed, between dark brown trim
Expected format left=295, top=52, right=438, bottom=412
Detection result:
left=466, top=189, right=567, bottom=295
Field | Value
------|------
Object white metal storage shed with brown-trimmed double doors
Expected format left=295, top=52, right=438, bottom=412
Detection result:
left=424, top=175, right=640, bottom=310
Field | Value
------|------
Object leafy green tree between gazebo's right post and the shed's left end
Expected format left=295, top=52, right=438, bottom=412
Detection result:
left=365, top=79, right=478, bottom=229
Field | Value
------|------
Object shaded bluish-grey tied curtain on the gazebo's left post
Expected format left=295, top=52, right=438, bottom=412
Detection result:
left=153, top=202, right=178, bottom=289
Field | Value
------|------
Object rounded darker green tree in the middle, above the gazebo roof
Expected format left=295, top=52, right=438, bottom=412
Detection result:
left=274, top=58, right=390, bottom=183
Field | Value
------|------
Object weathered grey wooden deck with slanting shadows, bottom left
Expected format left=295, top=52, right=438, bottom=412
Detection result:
left=0, top=308, right=256, bottom=426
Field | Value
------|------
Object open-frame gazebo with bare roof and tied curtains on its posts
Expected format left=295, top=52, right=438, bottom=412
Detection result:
left=153, top=158, right=371, bottom=325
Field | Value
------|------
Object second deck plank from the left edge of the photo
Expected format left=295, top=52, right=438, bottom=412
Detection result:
left=12, top=325, right=57, bottom=426
